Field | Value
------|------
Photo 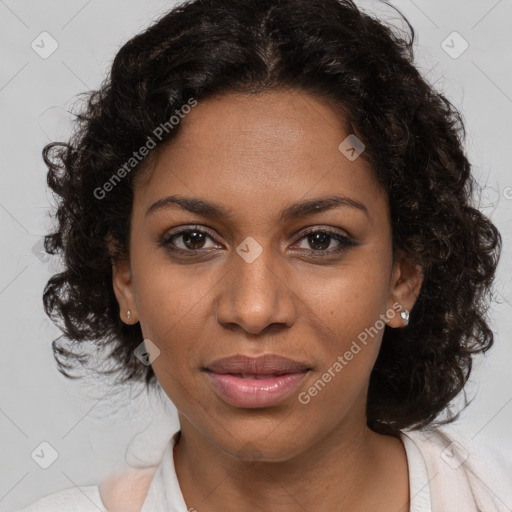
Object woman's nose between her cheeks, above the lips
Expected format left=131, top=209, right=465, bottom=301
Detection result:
left=216, top=248, right=297, bottom=334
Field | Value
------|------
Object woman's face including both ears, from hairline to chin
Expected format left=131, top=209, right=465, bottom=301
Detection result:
left=114, top=91, right=419, bottom=460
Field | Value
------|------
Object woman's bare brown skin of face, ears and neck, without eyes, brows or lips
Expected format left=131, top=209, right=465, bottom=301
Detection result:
left=113, top=91, right=422, bottom=512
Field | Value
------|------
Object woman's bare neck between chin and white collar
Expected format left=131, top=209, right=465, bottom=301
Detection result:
left=174, top=416, right=409, bottom=512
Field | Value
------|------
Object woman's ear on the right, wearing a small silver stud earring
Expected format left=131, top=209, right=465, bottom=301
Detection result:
left=386, top=250, right=423, bottom=327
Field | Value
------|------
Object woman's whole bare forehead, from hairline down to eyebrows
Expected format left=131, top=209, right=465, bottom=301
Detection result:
left=132, top=90, right=387, bottom=224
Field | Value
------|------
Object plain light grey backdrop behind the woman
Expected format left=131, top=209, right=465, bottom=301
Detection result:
left=0, top=0, right=512, bottom=511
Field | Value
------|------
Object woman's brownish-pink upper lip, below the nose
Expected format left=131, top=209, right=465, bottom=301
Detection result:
left=206, top=354, right=310, bottom=375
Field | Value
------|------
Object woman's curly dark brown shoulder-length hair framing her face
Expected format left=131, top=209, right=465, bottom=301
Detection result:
left=43, top=0, right=501, bottom=435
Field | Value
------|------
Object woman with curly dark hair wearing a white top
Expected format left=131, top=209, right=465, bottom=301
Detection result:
left=18, top=0, right=512, bottom=512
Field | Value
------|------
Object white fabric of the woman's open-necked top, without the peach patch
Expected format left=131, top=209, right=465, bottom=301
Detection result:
left=18, top=429, right=512, bottom=512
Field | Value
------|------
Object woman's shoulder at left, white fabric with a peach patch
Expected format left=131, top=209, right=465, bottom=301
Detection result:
left=17, top=466, right=157, bottom=512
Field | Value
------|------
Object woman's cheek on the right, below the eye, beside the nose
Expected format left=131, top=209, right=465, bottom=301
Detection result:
left=294, top=251, right=391, bottom=380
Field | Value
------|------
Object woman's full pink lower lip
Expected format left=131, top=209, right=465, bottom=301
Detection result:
left=206, top=371, right=307, bottom=408
